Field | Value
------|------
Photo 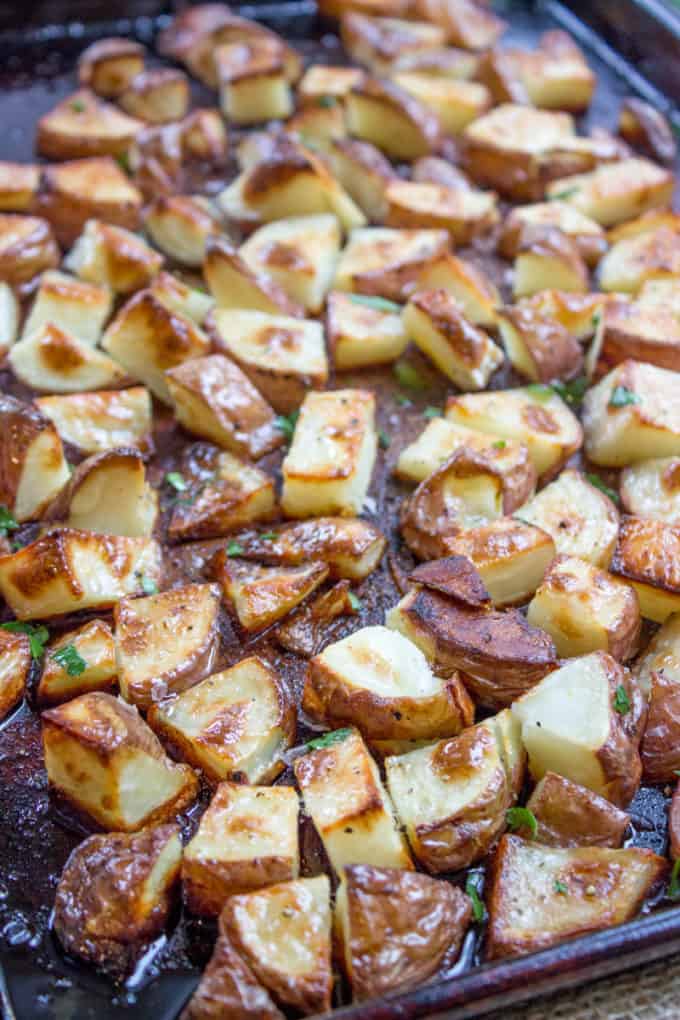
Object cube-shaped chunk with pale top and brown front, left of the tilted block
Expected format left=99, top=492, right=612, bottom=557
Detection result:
left=181, top=782, right=300, bottom=917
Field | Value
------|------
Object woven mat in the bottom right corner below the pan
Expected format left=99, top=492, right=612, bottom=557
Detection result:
left=485, top=957, right=680, bottom=1020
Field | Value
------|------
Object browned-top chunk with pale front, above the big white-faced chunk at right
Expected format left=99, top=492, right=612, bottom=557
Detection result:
left=527, top=556, right=640, bottom=662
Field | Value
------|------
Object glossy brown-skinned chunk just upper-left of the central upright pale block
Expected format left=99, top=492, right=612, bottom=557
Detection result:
left=165, top=354, right=283, bottom=459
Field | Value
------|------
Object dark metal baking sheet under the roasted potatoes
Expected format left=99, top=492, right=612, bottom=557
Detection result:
left=0, top=0, right=680, bottom=1020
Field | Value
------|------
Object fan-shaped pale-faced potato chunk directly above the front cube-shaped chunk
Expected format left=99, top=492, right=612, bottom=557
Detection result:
left=149, top=656, right=296, bottom=783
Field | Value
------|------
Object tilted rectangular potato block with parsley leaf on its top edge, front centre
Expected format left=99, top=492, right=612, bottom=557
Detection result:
left=294, top=729, right=413, bottom=875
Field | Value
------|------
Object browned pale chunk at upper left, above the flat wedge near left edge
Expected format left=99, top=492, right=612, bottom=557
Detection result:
left=64, top=219, right=163, bottom=294
